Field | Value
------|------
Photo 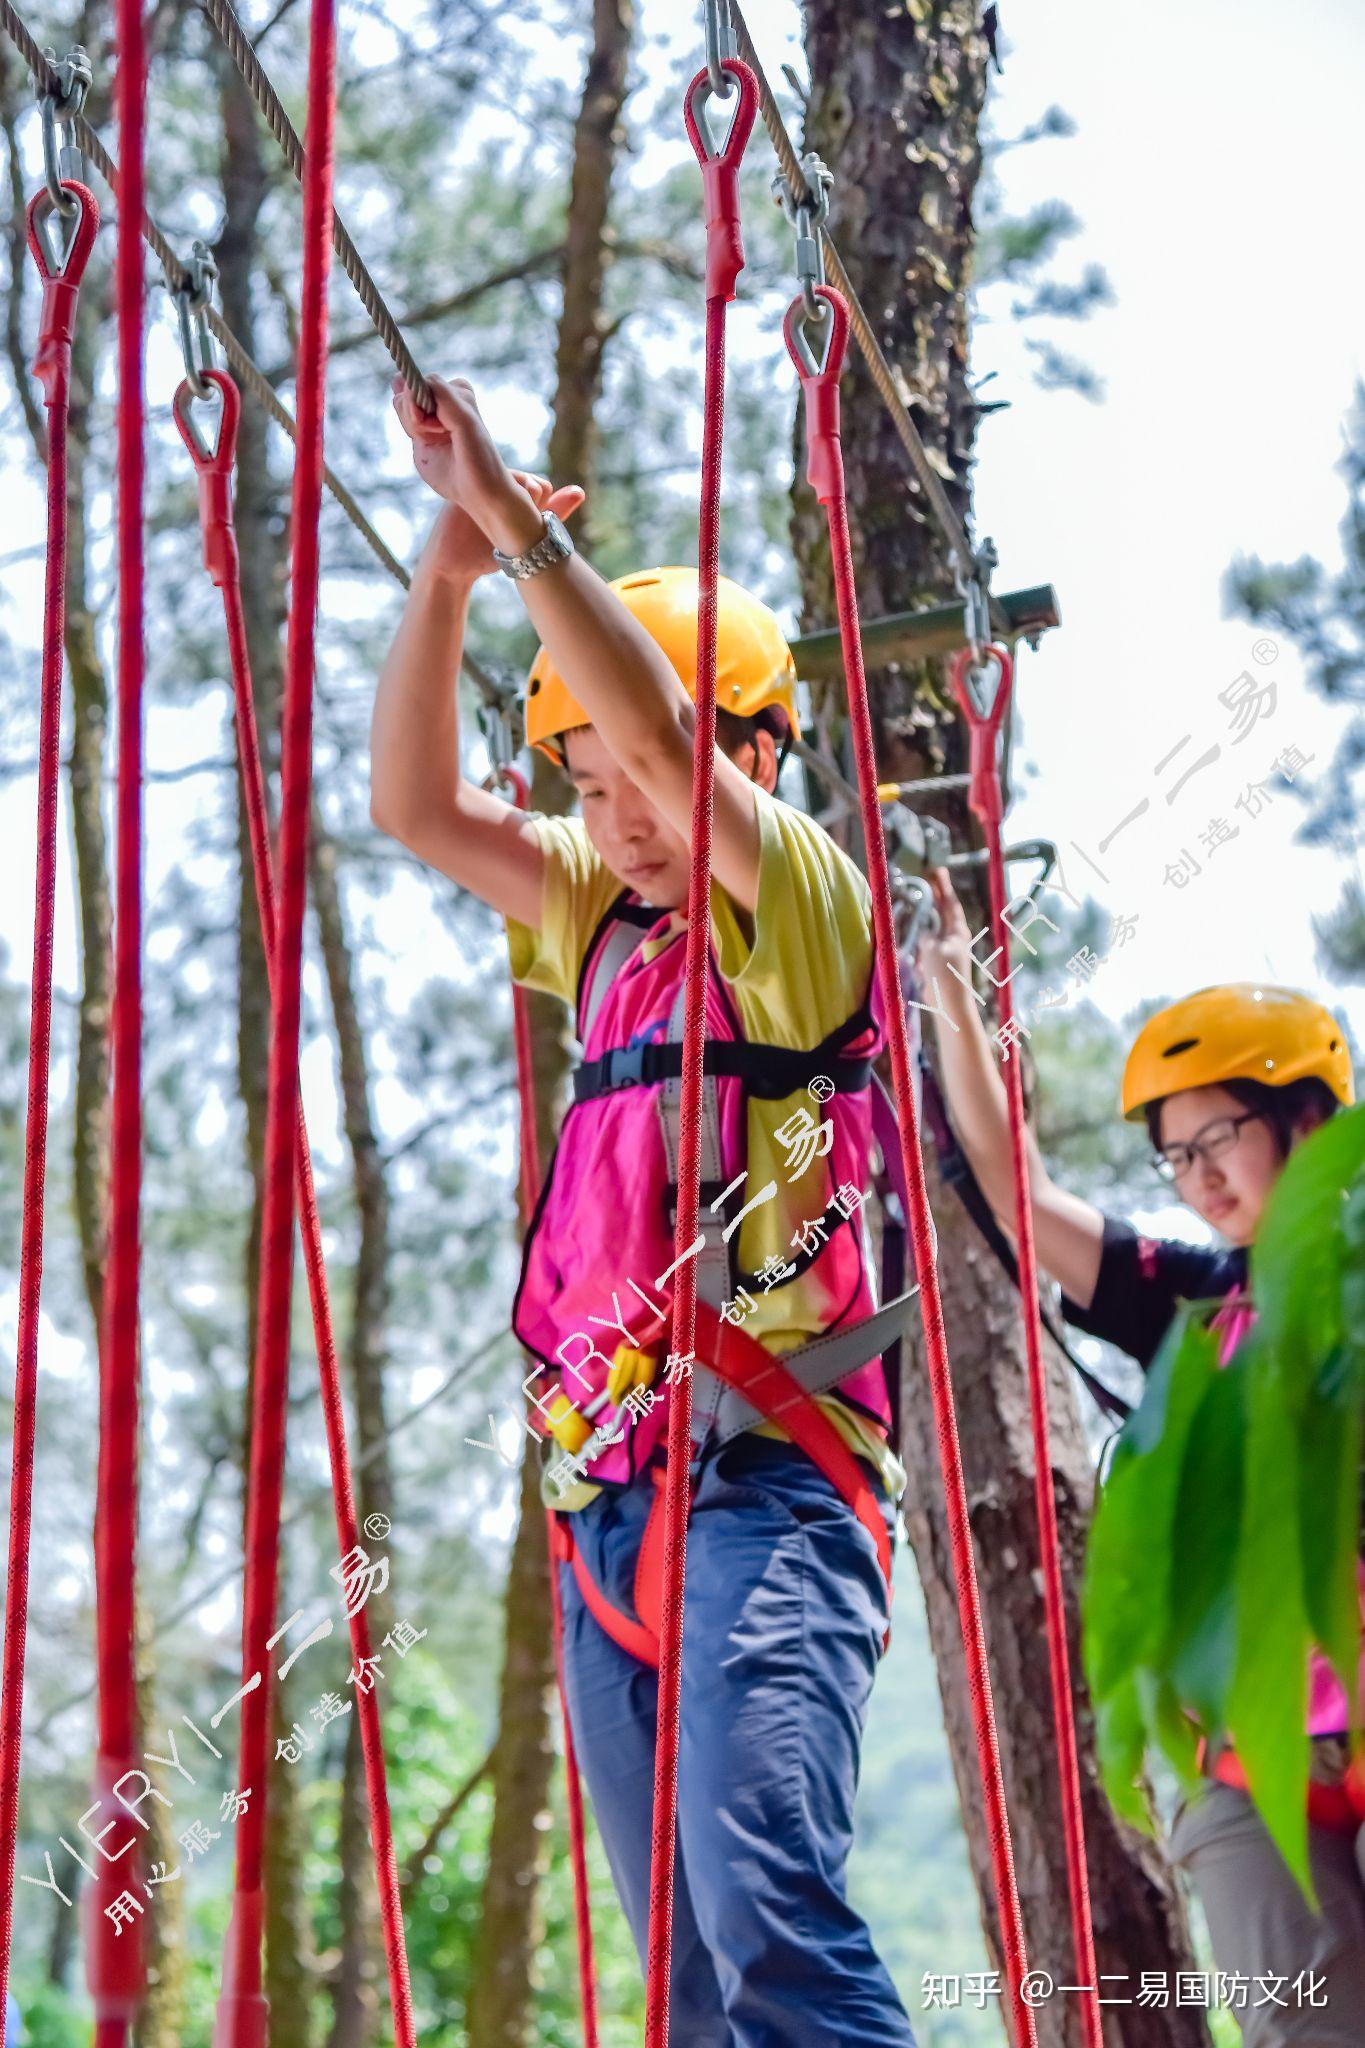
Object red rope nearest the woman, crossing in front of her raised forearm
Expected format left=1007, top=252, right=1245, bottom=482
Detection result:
left=952, top=647, right=1103, bottom=2048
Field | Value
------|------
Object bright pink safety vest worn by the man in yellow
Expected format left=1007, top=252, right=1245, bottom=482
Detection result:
left=512, top=891, right=890, bottom=1485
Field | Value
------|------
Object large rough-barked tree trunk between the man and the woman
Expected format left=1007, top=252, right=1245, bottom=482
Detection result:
left=792, top=0, right=1207, bottom=2048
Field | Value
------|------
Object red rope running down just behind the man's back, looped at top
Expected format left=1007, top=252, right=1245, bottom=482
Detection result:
left=782, top=285, right=1036, bottom=2048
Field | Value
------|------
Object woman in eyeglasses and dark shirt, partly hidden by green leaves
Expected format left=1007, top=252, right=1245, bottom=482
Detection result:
left=917, top=868, right=1365, bottom=2048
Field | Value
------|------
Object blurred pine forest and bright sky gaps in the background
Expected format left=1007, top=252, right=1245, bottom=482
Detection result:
left=0, top=0, right=1365, bottom=2048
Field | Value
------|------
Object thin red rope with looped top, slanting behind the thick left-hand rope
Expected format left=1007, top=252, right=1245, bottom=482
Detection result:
left=174, top=369, right=417, bottom=2048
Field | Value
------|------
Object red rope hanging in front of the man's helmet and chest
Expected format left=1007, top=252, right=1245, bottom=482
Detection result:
left=645, top=57, right=759, bottom=2048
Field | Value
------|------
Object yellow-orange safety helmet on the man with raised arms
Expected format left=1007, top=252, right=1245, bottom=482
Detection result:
left=526, top=569, right=800, bottom=760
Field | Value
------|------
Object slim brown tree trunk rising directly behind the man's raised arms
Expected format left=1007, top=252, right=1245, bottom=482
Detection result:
left=467, top=0, right=634, bottom=2048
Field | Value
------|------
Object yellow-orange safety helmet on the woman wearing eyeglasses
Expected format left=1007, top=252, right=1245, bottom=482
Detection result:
left=1124, top=981, right=1355, bottom=1122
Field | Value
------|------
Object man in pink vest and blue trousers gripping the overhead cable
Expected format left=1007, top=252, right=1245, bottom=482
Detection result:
left=370, top=381, right=913, bottom=2048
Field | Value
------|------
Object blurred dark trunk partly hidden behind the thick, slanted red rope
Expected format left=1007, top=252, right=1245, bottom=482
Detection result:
left=217, top=57, right=317, bottom=2048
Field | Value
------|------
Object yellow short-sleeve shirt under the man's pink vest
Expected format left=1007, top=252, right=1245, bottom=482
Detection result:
left=508, top=784, right=905, bottom=1509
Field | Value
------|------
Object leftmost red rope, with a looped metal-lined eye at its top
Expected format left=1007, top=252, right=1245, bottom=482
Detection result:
left=0, top=180, right=100, bottom=2013
